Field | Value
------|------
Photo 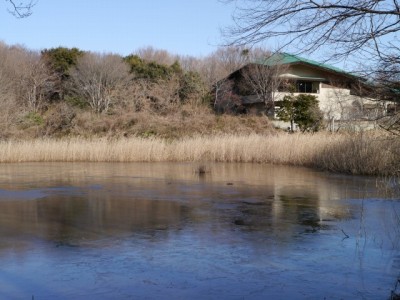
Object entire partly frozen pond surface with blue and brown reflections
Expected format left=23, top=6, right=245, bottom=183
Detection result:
left=0, top=163, right=400, bottom=300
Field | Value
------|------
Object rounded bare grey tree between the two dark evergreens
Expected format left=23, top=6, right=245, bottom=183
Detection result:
left=71, top=53, right=131, bottom=113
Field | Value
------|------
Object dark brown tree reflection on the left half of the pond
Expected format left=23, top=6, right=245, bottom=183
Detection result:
left=0, top=191, right=187, bottom=245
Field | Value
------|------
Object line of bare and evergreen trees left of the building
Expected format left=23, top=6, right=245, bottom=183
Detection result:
left=0, top=43, right=272, bottom=136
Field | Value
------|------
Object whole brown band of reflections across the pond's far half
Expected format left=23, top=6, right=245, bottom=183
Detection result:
left=0, top=163, right=378, bottom=253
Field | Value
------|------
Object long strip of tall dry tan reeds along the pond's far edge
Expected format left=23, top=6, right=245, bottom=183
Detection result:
left=0, top=133, right=400, bottom=175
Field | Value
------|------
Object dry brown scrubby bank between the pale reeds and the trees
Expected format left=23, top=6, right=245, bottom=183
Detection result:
left=0, top=104, right=275, bottom=140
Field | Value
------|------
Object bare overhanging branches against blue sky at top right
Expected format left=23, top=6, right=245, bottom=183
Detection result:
left=225, top=0, right=400, bottom=61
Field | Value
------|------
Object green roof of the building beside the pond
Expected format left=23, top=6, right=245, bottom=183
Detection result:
left=255, top=53, right=355, bottom=77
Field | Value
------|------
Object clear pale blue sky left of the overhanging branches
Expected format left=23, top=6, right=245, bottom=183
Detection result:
left=0, top=0, right=238, bottom=56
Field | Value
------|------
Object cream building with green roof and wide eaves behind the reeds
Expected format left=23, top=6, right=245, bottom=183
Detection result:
left=214, top=53, right=394, bottom=129
